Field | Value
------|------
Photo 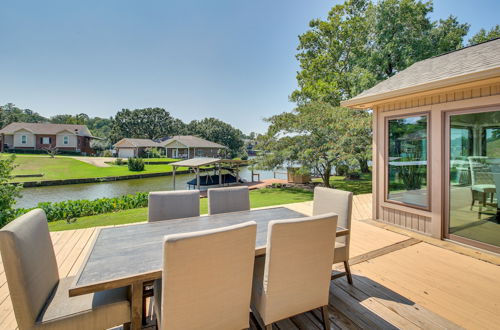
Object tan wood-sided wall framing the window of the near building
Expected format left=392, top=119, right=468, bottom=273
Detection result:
left=372, top=78, right=500, bottom=238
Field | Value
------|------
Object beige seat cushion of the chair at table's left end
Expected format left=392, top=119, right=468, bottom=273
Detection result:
left=37, top=277, right=130, bottom=330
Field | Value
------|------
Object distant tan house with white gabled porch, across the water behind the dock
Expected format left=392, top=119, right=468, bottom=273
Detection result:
left=160, top=135, right=228, bottom=159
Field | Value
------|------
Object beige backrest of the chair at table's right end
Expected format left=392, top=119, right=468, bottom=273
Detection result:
left=313, top=187, right=352, bottom=246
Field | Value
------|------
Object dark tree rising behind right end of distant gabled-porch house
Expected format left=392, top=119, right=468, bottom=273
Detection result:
left=187, top=118, right=243, bottom=157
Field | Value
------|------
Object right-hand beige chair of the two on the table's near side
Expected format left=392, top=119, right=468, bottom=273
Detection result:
left=251, top=213, right=338, bottom=330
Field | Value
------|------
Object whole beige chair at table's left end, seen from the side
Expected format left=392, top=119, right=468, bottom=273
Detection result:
left=0, top=209, right=130, bottom=330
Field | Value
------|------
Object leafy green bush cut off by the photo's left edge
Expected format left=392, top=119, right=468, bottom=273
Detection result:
left=0, top=155, right=21, bottom=227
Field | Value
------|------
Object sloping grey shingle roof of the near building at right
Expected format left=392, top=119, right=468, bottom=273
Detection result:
left=341, top=38, right=500, bottom=107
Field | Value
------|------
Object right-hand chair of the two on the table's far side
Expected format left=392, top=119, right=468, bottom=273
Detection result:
left=208, top=187, right=250, bottom=214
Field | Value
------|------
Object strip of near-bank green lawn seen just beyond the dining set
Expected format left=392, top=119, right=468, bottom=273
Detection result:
left=49, top=189, right=313, bottom=231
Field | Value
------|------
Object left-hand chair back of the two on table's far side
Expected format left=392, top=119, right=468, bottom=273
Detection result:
left=148, top=190, right=200, bottom=222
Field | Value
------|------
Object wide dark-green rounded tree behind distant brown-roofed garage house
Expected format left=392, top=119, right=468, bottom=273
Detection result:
left=111, top=108, right=179, bottom=142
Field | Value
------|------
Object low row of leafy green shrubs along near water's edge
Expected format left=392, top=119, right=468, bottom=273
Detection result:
left=17, top=193, right=148, bottom=221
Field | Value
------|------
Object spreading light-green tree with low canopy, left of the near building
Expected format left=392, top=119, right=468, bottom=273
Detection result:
left=258, top=101, right=371, bottom=187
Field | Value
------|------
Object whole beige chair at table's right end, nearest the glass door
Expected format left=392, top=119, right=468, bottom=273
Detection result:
left=313, top=187, right=352, bottom=284
